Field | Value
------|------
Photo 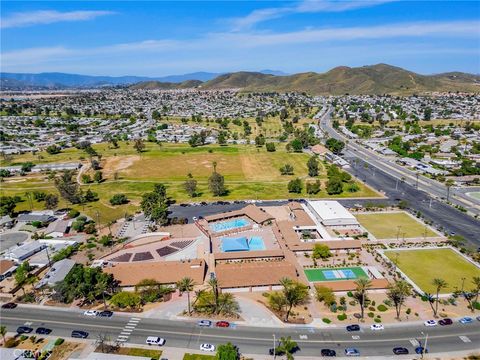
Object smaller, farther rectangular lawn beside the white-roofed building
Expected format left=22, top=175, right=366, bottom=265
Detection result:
left=355, top=212, right=438, bottom=239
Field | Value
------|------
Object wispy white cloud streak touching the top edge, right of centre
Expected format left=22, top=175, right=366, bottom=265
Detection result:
left=230, top=0, right=395, bottom=31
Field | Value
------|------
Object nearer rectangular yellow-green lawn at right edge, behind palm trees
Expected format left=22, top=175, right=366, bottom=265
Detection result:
left=385, top=249, right=480, bottom=294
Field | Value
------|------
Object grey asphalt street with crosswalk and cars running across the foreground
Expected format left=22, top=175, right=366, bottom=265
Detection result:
left=0, top=306, right=480, bottom=356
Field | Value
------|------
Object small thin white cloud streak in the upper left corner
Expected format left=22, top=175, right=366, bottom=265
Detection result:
left=1, top=10, right=114, bottom=29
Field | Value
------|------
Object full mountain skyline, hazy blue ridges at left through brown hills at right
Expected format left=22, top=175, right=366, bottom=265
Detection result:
left=0, top=64, right=480, bottom=95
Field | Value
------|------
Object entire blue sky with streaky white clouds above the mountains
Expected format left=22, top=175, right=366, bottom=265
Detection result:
left=0, top=0, right=480, bottom=76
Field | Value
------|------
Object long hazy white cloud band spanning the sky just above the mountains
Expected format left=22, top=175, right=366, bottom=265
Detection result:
left=1, top=21, right=480, bottom=73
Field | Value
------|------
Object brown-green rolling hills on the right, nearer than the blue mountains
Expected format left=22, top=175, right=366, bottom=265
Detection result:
left=196, top=64, right=480, bottom=95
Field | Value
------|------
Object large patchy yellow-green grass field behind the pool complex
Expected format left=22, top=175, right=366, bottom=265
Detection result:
left=0, top=143, right=379, bottom=223
